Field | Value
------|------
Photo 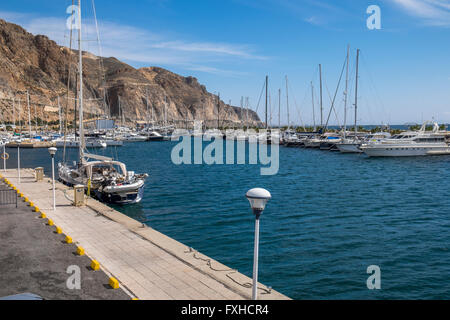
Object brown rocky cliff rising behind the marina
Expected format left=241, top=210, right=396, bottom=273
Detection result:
left=0, top=19, right=260, bottom=126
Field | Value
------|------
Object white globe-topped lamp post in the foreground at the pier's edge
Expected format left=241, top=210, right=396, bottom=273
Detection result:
left=246, top=188, right=272, bottom=300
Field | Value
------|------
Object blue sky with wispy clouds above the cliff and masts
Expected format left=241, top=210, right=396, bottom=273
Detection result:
left=0, top=0, right=450, bottom=124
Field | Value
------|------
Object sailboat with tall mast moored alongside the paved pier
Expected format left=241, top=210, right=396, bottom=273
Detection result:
left=58, top=0, right=148, bottom=204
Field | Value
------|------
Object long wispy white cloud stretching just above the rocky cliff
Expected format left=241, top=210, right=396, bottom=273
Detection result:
left=0, top=12, right=266, bottom=75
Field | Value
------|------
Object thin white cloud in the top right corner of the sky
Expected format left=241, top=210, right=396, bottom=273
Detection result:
left=389, top=0, right=450, bottom=26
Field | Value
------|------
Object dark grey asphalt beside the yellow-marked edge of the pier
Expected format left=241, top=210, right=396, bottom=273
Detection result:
left=0, top=182, right=131, bottom=300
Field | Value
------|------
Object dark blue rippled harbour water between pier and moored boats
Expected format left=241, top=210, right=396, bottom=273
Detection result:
left=4, top=142, right=450, bottom=299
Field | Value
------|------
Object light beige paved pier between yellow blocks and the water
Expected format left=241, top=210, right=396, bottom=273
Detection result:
left=0, top=169, right=289, bottom=300
